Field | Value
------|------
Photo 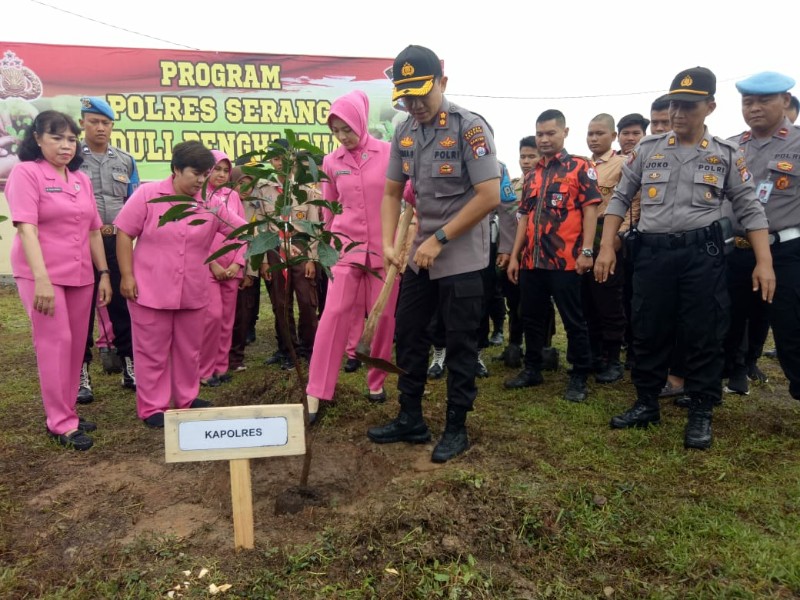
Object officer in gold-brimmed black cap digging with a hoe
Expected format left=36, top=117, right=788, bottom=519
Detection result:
left=367, top=46, right=500, bottom=462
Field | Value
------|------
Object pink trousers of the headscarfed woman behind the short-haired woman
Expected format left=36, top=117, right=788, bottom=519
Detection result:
left=200, top=279, right=242, bottom=379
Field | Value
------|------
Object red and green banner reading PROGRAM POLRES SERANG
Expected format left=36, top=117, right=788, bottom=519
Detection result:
left=0, top=41, right=405, bottom=186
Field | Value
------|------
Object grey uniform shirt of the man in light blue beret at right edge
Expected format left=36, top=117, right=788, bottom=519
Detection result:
left=729, top=117, right=800, bottom=232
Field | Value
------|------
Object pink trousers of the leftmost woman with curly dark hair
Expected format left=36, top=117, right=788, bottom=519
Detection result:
left=16, top=278, right=94, bottom=435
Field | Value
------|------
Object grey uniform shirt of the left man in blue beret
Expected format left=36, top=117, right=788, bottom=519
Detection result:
left=81, top=143, right=139, bottom=224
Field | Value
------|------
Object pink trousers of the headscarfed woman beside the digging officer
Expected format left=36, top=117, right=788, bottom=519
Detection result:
left=306, top=264, right=399, bottom=400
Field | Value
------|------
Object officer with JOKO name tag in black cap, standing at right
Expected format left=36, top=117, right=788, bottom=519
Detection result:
left=595, top=67, right=775, bottom=449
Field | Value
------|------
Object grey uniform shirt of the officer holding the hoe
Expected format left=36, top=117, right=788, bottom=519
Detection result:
left=387, top=98, right=500, bottom=279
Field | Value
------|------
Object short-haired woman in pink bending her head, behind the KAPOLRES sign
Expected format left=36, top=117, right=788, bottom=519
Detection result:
left=114, top=142, right=245, bottom=427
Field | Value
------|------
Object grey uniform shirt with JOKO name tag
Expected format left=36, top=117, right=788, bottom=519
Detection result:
left=606, top=128, right=767, bottom=233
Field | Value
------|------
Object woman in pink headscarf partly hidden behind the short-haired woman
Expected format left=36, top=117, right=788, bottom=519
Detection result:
left=200, top=150, right=245, bottom=387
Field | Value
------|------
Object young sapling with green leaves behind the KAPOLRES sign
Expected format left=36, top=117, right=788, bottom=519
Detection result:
left=151, top=129, right=366, bottom=496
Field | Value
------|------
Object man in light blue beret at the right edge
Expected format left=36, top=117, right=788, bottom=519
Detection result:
left=729, top=71, right=800, bottom=400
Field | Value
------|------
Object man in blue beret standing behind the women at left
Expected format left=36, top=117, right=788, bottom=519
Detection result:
left=78, top=97, right=139, bottom=404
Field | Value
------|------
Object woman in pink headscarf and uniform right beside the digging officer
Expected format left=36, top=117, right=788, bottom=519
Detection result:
left=306, top=90, right=398, bottom=422
